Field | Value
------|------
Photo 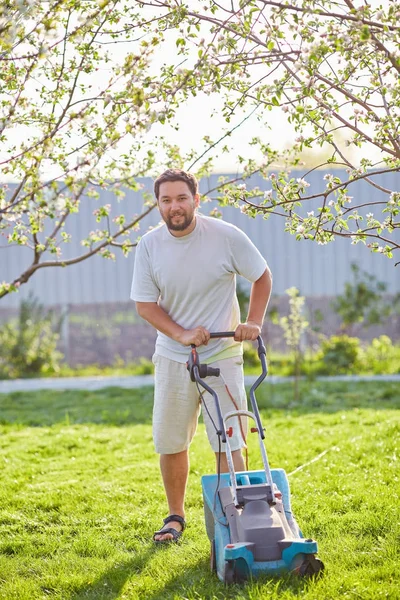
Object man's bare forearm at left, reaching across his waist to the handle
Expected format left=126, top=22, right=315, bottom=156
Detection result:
left=136, top=302, right=210, bottom=346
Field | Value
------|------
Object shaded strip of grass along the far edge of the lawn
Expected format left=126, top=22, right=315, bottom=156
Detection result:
left=0, top=381, right=400, bottom=426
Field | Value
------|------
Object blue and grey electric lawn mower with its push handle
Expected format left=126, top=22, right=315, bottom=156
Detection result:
left=187, top=332, right=324, bottom=584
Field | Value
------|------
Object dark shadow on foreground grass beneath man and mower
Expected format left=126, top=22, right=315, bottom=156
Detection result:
left=69, top=546, right=310, bottom=600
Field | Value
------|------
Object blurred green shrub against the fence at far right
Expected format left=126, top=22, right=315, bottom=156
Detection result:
left=332, top=264, right=399, bottom=332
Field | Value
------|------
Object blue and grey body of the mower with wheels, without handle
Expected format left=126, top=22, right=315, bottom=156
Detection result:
left=202, top=469, right=323, bottom=583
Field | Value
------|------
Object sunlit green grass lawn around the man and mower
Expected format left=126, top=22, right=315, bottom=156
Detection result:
left=0, top=382, right=400, bottom=600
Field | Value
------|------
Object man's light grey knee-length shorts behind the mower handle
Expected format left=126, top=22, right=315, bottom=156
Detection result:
left=153, top=354, right=247, bottom=454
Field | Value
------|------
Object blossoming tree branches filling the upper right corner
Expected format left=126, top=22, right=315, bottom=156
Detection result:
left=146, top=0, right=400, bottom=257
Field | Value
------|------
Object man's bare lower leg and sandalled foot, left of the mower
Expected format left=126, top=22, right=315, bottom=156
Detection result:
left=155, top=450, right=189, bottom=542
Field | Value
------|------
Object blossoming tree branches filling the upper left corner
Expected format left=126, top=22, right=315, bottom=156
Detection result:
left=0, top=0, right=219, bottom=298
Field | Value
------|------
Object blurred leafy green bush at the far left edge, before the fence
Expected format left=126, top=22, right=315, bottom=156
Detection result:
left=0, top=297, right=62, bottom=379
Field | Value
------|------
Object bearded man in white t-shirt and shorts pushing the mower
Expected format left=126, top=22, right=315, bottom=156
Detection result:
left=131, top=169, right=272, bottom=542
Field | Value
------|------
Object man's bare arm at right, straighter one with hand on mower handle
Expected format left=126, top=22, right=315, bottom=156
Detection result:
left=235, top=267, right=272, bottom=342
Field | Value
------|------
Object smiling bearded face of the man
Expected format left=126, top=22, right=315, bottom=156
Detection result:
left=158, top=181, right=200, bottom=232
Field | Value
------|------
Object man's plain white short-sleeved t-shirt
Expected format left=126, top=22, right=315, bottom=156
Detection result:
left=131, top=213, right=267, bottom=362
